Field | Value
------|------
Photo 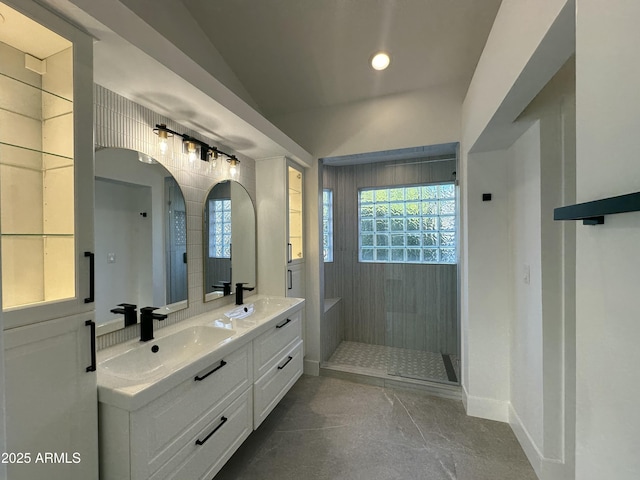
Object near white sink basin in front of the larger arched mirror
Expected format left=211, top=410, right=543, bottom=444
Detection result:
left=98, top=326, right=236, bottom=381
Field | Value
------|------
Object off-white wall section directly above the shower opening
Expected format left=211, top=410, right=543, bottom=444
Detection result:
left=271, top=85, right=464, bottom=158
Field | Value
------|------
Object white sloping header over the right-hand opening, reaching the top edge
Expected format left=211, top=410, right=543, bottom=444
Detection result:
left=462, top=0, right=575, bottom=151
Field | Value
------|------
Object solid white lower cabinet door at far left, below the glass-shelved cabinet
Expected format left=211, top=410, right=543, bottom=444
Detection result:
left=4, top=315, right=98, bottom=480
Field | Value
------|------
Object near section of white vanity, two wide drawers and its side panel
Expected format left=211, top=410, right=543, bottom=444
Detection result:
left=100, top=343, right=253, bottom=480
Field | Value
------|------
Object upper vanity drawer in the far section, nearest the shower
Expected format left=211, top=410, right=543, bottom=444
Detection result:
left=253, top=310, right=302, bottom=379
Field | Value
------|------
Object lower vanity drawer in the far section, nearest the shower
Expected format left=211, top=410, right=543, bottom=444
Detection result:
left=253, top=340, right=303, bottom=429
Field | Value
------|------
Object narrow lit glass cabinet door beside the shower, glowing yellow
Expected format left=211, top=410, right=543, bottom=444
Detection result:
left=287, top=162, right=304, bottom=263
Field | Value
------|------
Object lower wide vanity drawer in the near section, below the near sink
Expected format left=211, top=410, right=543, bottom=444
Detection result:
left=150, top=388, right=253, bottom=480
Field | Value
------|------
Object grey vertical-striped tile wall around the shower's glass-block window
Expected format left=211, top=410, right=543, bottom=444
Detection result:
left=323, top=159, right=459, bottom=354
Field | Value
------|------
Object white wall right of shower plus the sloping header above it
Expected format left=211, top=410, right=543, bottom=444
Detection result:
left=460, top=0, right=573, bottom=421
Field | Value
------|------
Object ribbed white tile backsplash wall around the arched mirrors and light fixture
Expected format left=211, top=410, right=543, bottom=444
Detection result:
left=94, top=85, right=256, bottom=349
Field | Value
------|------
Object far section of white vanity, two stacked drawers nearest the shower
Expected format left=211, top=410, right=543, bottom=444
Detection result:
left=253, top=310, right=303, bottom=428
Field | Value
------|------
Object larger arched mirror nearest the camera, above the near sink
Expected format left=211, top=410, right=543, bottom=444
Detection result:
left=95, top=148, right=188, bottom=334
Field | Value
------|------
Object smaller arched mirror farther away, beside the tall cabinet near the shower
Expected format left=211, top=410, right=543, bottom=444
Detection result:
left=203, top=180, right=256, bottom=302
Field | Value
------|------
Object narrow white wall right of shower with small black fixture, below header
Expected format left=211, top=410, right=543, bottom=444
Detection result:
left=461, top=150, right=509, bottom=422
